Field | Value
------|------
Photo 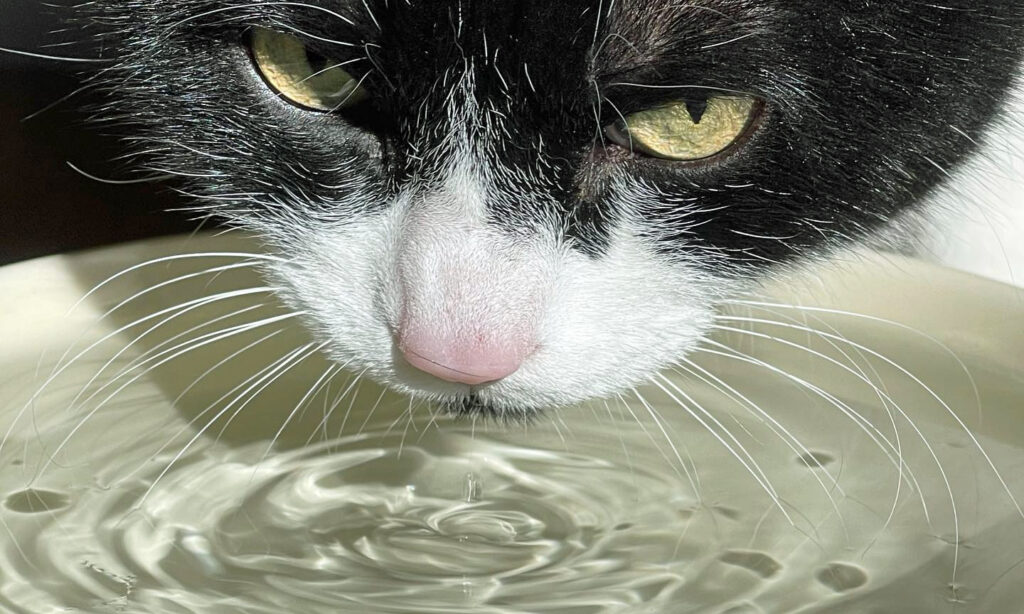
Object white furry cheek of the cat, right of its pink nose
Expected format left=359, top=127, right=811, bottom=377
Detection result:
left=481, top=235, right=716, bottom=406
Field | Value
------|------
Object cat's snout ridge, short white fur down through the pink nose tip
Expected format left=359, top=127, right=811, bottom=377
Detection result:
left=395, top=208, right=551, bottom=386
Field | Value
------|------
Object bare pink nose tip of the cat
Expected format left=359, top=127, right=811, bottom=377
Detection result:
left=398, top=334, right=532, bottom=386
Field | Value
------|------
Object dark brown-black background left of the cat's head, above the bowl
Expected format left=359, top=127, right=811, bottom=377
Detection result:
left=0, top=0, right=196, bottom=264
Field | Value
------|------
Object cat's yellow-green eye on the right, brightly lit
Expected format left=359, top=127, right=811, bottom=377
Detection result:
left=605, top=95, right=761, bottom=162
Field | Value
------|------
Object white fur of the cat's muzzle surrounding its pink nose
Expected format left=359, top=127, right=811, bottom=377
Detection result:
left=264, top=164, right=722, bottom=409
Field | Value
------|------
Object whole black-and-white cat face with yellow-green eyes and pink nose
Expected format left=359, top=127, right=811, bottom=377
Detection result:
left=85, top=0, right=1024, bottom=416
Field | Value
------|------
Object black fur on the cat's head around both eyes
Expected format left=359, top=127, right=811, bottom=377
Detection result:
left=79, top=0, right=1024, bottom=271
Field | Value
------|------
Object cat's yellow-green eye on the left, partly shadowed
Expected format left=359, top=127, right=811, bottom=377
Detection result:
left=249, top=28, right=367, bottom=112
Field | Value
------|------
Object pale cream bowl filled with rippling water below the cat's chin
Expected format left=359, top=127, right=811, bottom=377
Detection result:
left=0, top=239, right=1024, bottom=614
